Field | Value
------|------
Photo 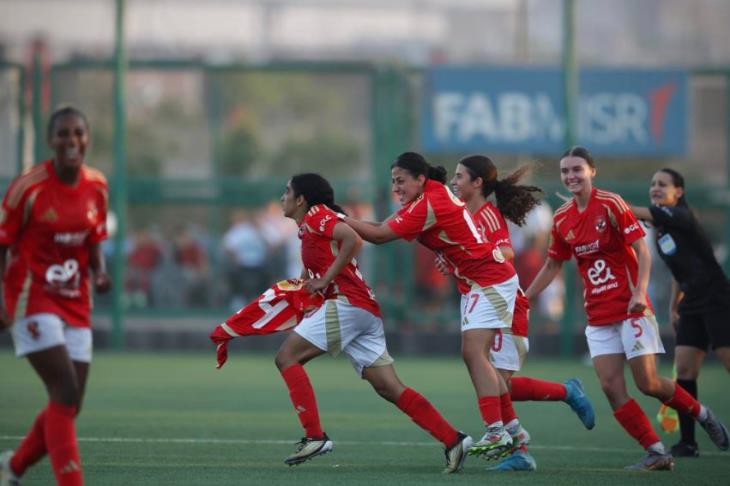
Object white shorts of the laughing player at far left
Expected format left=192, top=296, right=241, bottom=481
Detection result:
left=10, top=313, right=92, bottom=363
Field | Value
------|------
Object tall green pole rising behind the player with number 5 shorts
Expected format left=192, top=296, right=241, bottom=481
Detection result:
left=560, top=0, right=579, bottom=356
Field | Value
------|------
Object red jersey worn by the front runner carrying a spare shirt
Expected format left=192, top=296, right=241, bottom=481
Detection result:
left=299, top=204, right=381, bottom=317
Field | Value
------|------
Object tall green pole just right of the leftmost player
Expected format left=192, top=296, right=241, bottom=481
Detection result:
left=112, top=0, right=127, bottom=349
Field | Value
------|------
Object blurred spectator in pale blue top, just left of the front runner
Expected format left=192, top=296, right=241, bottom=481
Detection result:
left=223, top=209, right=270, bottom=309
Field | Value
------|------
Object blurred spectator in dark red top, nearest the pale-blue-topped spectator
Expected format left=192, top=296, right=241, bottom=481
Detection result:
left=173, top=226, right=210, bottom=307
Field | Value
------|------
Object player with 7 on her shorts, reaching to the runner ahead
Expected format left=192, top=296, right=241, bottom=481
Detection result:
left=344, top=152, right=518, bottom=458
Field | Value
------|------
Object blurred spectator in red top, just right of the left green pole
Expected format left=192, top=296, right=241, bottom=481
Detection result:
left=125, top=228, right=163, bottom=307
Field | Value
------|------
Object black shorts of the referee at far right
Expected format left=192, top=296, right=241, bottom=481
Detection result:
left=677, top=306, right=730, bottom=351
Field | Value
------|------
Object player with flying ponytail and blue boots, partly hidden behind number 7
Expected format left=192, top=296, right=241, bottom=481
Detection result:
left=451, top=155, right=595, bottom=470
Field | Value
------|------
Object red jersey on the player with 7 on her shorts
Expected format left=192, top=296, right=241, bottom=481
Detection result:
left=388, top=180, right=515, bottom=294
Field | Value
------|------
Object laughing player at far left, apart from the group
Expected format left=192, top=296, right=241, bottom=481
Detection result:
left=0, top=107, right=110, bottom=485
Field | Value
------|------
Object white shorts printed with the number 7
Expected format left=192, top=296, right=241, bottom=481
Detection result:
left=461, top=275, right=519, bottom=332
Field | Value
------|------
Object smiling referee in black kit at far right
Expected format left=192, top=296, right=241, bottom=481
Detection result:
left=631, top=169, right=730, bottom=457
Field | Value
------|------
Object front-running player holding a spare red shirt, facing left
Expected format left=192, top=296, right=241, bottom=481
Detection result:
left=276, top=174, right=472, bottom=473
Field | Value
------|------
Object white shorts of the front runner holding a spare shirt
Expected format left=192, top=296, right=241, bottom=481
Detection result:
left=294, top=299, right=393, bottom=376
